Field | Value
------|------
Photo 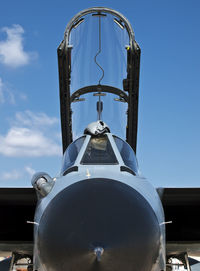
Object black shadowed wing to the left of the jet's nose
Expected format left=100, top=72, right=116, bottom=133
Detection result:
left=0, top=188, right=37, bottom=253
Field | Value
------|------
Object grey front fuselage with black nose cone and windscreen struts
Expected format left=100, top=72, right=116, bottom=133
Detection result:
left=34, top=134, right=165, bottom=271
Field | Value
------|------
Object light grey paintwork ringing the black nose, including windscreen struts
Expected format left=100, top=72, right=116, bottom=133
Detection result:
left=34, top=133, right=165, bottom=271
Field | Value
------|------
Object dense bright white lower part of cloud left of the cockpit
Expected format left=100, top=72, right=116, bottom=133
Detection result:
left=0, top=127, right=61, bottom=157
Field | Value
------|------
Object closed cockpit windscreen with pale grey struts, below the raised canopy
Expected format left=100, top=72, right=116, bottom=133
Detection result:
left=61, top=126, right=138, bottom=175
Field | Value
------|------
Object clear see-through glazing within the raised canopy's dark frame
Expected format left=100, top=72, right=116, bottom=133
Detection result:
left=69, top=13, right=129, bottom=139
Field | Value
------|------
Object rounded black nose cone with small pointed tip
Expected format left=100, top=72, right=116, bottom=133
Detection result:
left=38, top=179, right=160, bottom=271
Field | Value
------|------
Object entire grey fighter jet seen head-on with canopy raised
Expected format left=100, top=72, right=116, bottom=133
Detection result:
left=0, top=7, right=200, bottom=271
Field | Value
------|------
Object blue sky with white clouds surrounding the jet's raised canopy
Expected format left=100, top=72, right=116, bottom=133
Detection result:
left=0, top=0, right=200, bottom=187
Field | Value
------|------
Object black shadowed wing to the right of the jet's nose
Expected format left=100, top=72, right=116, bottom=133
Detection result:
left=157, top=188, right=200, bottom=256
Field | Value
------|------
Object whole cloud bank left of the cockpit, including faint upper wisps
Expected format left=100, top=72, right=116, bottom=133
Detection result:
left=0, top=110, right=62, bottom=157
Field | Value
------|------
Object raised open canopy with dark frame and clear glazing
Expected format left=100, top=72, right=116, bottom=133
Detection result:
left=58, top=8, right=140, bottom=152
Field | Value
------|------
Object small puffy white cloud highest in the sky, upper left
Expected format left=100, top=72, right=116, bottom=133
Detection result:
left=0, top=24, right=36, bottom=68
